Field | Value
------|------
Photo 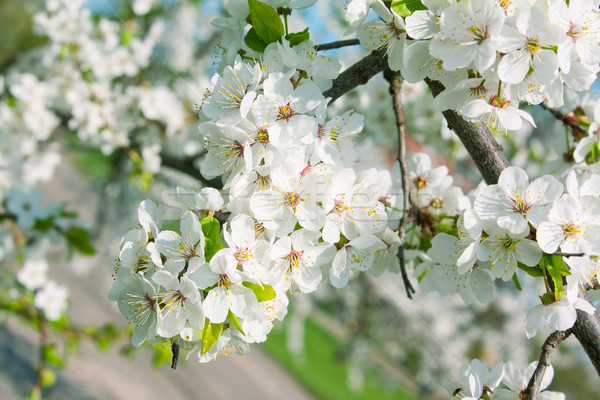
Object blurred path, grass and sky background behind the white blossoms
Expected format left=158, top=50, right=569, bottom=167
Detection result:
left=0, top=0, right=598, bottom=399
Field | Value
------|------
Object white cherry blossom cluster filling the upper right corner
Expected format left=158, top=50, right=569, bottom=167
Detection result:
left=346, top=0, right=600, bottom=132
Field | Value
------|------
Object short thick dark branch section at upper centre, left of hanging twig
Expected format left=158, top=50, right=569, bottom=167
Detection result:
left=323, top=50, right=387, bottom=102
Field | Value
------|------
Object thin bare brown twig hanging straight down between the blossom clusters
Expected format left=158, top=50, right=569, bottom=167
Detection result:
left=383, top=68, right=415, bottom=299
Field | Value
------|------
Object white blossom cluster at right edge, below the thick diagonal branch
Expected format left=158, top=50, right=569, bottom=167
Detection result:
left=420, top=167, right=600, bottom=337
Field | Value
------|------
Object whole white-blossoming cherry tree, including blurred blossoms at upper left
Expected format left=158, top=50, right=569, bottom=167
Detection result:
left=0, top=0, right=600, bottom=399
